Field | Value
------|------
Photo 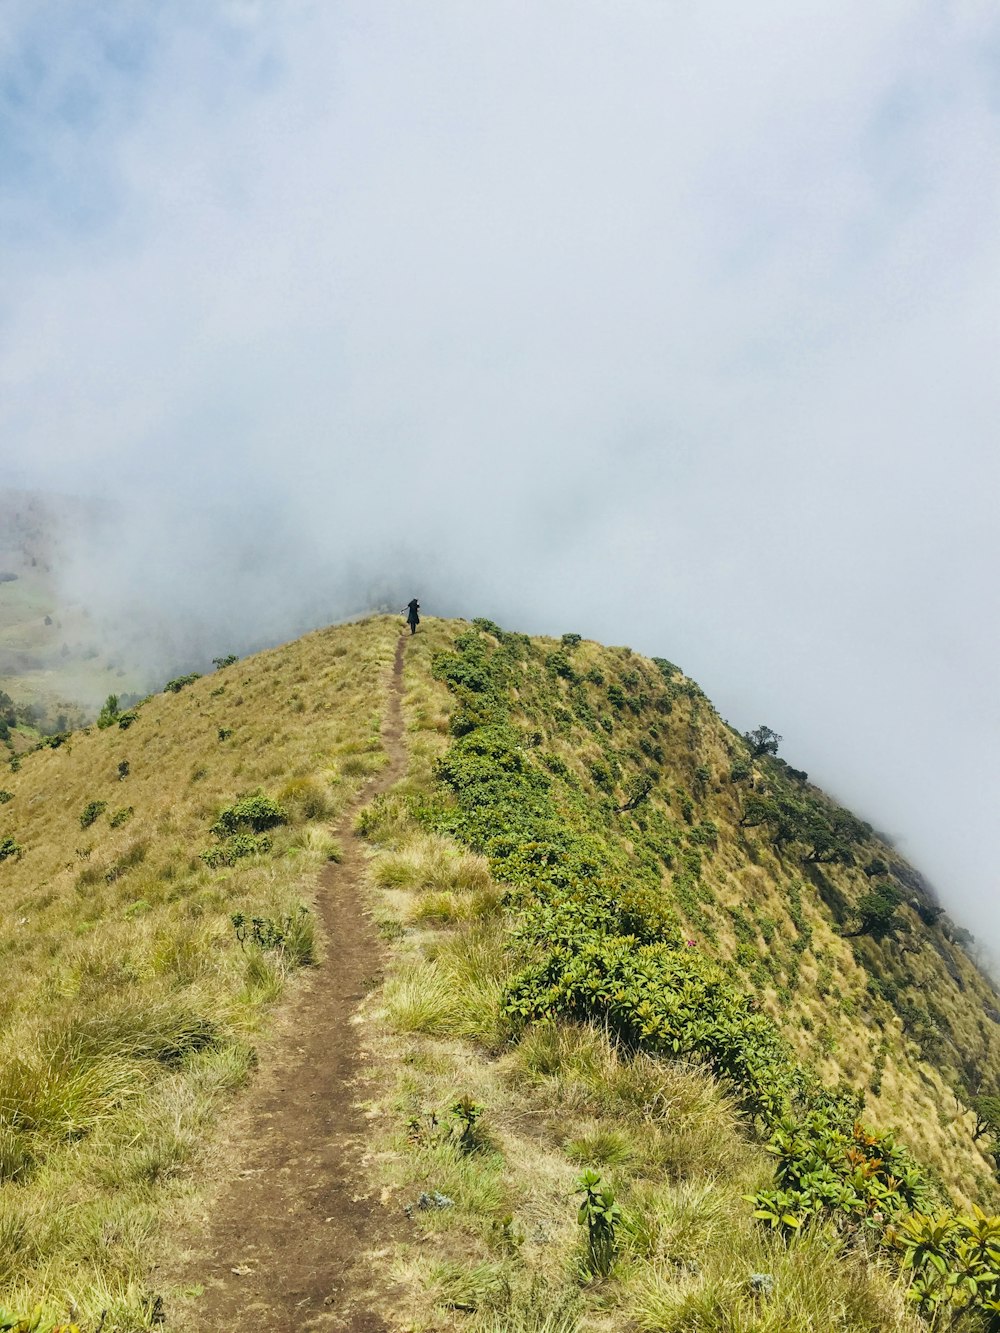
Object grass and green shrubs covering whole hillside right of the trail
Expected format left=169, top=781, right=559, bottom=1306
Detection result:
left=361, top=623, right=1000, bottom=1330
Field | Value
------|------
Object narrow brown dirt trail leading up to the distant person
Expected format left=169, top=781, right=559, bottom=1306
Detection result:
left=167, top=639, right=407, bottom=1333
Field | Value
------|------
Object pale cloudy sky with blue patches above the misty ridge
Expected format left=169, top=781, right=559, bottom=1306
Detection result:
left=0, top=10, right=1000, bottom=948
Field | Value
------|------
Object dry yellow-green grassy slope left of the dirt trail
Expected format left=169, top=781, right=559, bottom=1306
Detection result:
left=0, top=620, right=397, bottom=1329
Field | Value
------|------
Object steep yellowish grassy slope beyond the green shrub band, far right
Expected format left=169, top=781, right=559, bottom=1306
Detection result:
left=493, top=618, right=1000, bottom=1204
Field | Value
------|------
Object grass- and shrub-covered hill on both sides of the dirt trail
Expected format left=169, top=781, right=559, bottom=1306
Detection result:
left=0, top=617, right=1000, bottom=1333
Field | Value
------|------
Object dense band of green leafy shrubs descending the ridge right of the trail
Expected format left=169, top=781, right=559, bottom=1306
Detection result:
left=424, top=621, right=954, bottom=1273
